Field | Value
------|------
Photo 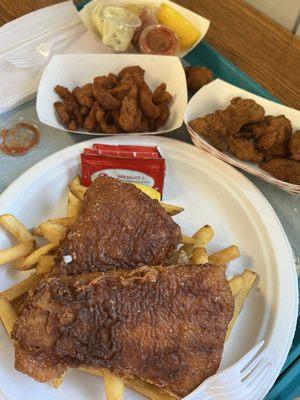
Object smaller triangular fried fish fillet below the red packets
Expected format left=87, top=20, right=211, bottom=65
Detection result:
left=54, top=176, right=181, bottom=275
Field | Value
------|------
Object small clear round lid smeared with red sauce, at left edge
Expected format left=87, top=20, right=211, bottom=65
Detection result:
left=0, top=122, right=40, bottom=155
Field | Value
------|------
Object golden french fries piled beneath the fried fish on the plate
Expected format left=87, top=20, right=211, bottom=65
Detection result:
left=0, top=176, right=257, bottom=400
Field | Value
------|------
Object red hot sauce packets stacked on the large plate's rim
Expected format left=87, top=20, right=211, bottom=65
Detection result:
left=81, top=144, right=166, bottom=194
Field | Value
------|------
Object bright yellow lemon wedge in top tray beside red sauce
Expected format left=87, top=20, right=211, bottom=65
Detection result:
left=156, top=3, right=200, bottom=48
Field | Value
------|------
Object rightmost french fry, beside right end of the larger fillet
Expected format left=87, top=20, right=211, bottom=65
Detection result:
left=225, top=269, right=257, bottom=340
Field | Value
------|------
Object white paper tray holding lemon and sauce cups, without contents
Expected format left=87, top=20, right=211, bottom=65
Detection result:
left=78, top=0, right=210, bottom=57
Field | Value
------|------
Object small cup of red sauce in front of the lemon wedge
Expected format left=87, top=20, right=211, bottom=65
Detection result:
left=139, top=25, right=178, bottom=55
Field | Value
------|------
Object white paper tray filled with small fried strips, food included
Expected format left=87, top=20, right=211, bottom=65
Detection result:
left=37, top=54, right=187, bottom=135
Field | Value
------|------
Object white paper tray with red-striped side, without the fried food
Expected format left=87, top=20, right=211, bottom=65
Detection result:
left=184, top=79, right=300, bottom=194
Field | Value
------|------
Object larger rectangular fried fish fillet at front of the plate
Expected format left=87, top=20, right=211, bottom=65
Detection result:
left=12, top=264, right=234, bottom=397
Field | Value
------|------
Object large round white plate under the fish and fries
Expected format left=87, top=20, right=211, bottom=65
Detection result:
left=0, top=137, right=298, bottom=400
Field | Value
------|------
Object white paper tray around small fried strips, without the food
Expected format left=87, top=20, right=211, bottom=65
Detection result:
left=36, top=54, right=187, bottom=136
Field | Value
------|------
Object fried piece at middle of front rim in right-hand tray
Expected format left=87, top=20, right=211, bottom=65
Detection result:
left=228, top=137, right=264, bottom=163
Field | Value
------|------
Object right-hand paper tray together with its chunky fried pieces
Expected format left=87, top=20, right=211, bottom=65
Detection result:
left=185, top=79, right=300, bottom=194
